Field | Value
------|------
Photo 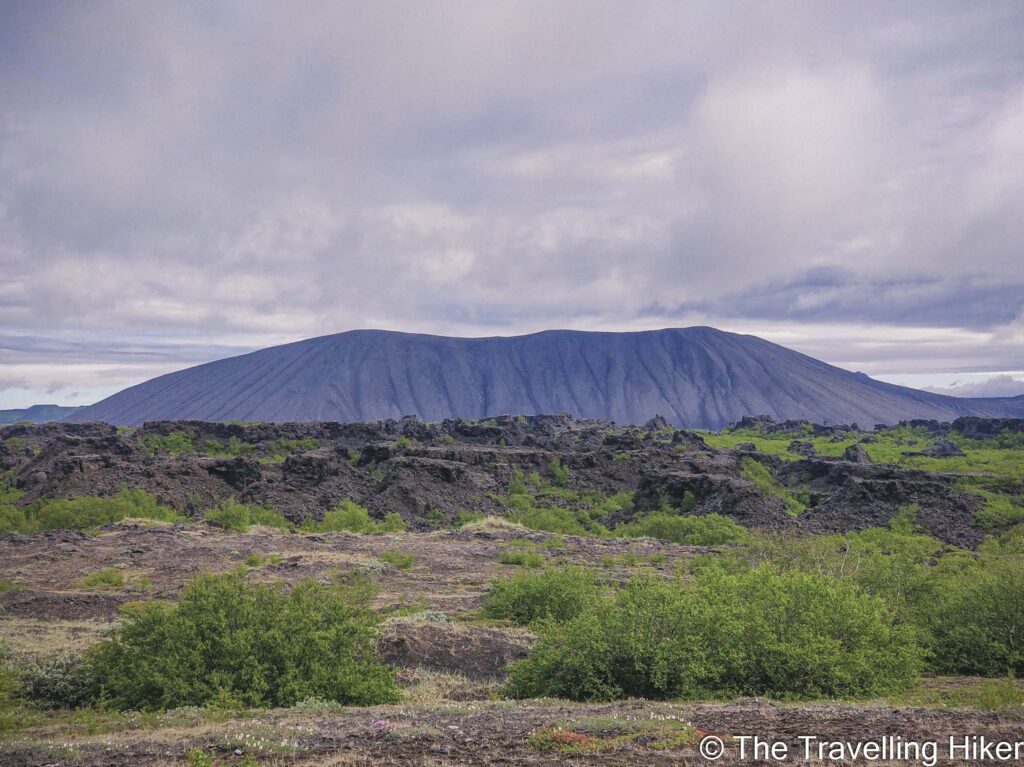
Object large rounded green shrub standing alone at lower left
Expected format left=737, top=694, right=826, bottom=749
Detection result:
left=85, top=574, right=398, bottom=711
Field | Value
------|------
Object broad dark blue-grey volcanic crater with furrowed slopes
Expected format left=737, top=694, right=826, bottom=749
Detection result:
left=69, top=328, right=1024, bottom=428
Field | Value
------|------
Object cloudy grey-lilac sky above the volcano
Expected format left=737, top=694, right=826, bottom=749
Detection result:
left=0, top=0, right=1024, bottom=408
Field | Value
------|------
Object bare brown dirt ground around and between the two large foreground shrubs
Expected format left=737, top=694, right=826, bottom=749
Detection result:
left=0, top=522, right=1024, bottom=767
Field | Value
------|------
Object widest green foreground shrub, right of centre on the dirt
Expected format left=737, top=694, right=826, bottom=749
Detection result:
left=506, top=567, right=922, bottom=700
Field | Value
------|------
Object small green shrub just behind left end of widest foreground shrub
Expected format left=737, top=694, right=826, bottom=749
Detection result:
left=482, top=567, right=601, bottom=626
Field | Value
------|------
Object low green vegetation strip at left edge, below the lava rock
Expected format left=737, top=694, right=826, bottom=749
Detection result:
left=0, top=482, right=185, bottom=532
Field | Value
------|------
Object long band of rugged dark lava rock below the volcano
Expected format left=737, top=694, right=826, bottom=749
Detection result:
left=0, top=415, right=1007, bottom=545
